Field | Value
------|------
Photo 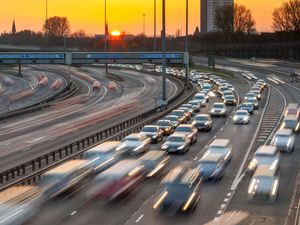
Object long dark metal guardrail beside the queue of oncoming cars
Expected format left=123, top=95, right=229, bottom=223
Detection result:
left=0, top=74, right=196, bottom=191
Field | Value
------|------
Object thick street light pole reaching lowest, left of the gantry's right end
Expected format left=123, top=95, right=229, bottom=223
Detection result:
left=161, top=0, right=167, bottom=101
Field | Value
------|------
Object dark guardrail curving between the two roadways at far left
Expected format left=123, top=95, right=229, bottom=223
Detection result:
left=0, top=73, right=77, bottom=121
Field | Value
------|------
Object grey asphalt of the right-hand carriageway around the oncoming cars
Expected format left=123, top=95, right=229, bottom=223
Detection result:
left=0, top=60, right=300, bottom=225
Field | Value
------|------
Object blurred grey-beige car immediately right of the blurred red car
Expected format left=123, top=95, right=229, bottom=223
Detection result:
left=138, top=150, right=170, bottom=177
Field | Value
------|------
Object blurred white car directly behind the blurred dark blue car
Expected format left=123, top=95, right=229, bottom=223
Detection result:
left=206, top=139, right=232, bottom=164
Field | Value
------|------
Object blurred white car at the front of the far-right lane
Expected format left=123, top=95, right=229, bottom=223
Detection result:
left=248, top=165, right=279, bottom=202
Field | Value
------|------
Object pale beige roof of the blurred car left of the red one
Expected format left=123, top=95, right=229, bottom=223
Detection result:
left=45, top=159, right=89, bottom=175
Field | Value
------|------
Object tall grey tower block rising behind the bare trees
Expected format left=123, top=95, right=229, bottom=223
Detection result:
left=200, top=0, right=234, bottom=33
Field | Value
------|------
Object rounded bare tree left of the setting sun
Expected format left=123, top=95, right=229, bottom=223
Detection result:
left=43, top=16, right=71, bottom=37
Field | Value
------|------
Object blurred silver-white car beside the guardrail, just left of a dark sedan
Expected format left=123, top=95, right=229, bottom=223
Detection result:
left=117, top=133, right=151, bottom=155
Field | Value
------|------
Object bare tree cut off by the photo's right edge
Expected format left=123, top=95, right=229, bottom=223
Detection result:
left=272, top=0, right=300, bottom=31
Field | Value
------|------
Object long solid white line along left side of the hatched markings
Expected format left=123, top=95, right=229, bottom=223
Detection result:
left=231, top=83, right=271, bottom=190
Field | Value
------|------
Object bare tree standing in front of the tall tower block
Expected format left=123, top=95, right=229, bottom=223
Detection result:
left=215, top=4, right=255, bottom=35
